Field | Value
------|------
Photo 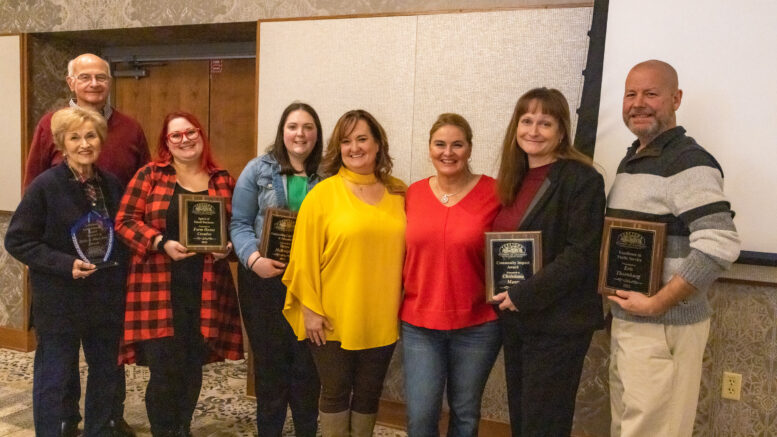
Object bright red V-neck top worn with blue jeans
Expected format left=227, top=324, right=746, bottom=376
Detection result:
left=399, top=175, right=499, bottom=330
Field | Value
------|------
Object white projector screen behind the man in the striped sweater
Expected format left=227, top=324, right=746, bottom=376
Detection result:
left=594, top=0, right=777, bottom=253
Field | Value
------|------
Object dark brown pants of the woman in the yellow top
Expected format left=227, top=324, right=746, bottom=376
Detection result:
left=308, top=341, right=396, bottom=414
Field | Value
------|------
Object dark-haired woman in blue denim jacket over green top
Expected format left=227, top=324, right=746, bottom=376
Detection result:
left=230, top=103, right=323, bottom=437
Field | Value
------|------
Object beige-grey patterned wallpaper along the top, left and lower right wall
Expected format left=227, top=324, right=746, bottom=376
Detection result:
left=0, top=0, right=777, bottom=437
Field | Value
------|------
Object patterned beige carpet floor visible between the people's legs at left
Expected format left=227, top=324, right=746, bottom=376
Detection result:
left=0, top=349, right=407, bottom=437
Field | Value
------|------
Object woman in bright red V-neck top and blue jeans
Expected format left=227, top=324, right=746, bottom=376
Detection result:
left=400, top=114, right=501, bottom=437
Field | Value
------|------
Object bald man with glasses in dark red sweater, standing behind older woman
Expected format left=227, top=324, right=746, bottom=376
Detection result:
left=24, top=53, right=150, bottom=437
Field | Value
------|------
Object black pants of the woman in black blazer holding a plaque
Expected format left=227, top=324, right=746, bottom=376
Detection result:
left=500, top=320, right=593, bottom=437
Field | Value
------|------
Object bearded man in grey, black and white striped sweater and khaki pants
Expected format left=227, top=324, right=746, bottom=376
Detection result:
left=607, top=60, right=739, bottom=437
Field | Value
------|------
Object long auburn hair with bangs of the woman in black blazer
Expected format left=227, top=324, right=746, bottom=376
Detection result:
left=496, top=87, right=593, bottom=205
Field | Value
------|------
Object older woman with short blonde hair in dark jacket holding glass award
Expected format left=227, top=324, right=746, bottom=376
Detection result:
left=5, top=107, right=127, bottom=437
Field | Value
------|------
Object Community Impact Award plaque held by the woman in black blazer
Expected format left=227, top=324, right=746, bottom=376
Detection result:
left=486, top=231, right=542, bottom=303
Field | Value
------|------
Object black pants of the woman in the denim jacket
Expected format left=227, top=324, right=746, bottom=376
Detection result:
left=238, top=265, right=320, bottom=437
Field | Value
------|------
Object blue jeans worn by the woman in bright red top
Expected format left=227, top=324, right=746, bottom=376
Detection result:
left=402, top=321, right=502, bottom=437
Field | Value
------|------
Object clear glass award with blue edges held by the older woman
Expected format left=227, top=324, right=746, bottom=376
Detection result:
left=70, top=211, right=119, bottom=269
